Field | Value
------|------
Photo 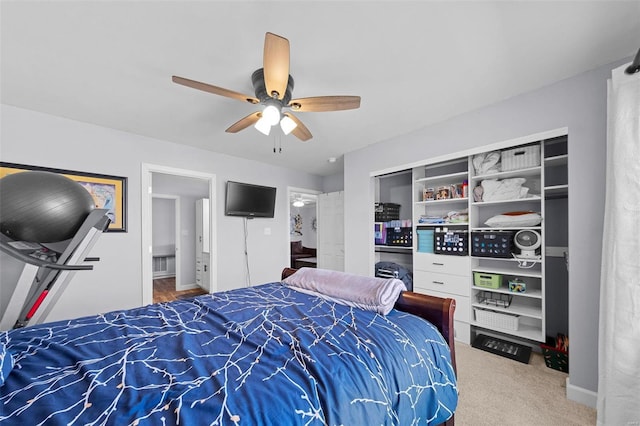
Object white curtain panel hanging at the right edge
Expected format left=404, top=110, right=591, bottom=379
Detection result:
left=597, top=59, right=640, bottom=425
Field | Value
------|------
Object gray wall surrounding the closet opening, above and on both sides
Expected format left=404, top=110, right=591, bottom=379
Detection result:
left=344, top=59, right=630, bottom=402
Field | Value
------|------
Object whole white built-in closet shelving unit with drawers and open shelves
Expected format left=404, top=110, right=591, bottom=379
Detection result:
left=404, top=131, right=569, bottom=343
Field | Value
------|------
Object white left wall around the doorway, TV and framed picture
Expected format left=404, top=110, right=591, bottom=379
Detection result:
left=0, top=105, right=322, bottom=320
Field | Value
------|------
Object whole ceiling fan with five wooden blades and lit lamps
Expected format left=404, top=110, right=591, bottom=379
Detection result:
left=171, top=33, right=360, bottom=141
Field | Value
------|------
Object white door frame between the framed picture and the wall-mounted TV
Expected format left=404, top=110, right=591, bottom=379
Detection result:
left=140, top=163, right=218, bottom=305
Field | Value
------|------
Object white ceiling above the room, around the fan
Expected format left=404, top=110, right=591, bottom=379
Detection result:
left=0, top=0, right=640, bottom=175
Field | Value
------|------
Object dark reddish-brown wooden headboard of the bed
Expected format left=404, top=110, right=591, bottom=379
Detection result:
left=282, top=268, right=457, bottom=371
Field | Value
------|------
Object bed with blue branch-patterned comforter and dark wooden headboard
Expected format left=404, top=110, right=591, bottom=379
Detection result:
left=0, top=268, right=458, bottom=425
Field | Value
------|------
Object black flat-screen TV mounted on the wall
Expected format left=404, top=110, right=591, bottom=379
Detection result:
left=224, top=181, right=276, bottom=218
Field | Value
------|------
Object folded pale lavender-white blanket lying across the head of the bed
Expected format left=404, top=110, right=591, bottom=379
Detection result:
left=283, top=268, right=407, bottom=315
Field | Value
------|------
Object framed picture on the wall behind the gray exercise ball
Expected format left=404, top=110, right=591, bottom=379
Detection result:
left=0, top=161, right=127, bottom=232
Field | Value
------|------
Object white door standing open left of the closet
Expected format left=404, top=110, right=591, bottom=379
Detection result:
left=317, top=191, right=344, bottom=271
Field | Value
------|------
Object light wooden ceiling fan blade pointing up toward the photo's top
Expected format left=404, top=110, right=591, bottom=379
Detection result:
left=263, top=33, right=289, bottom=99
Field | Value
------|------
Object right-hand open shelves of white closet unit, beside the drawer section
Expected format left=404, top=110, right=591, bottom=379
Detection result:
left=469, top=136, right=569, bottom=342
